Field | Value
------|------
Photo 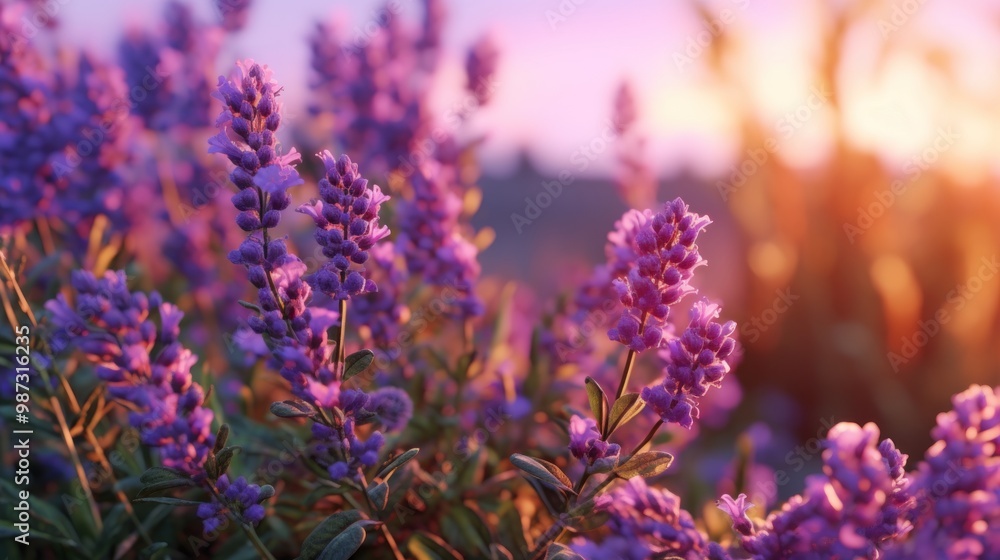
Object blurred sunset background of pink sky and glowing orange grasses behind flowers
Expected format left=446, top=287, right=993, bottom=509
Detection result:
left=17, top=0, right=1000, bottom=474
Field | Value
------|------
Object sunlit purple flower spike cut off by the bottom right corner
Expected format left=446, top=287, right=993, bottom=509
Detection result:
left=892, top=385, right=1000, bottom=558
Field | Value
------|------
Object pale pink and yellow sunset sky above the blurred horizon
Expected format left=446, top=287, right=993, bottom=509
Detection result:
left=41, top=0, right=1000, bottom=181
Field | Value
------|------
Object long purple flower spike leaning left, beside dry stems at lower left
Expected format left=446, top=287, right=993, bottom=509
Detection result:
left=45, top=271, right=215, bottom=475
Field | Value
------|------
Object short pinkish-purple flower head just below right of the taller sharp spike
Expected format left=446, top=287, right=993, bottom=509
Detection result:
left=642, top=300, right=736, bottom=428
